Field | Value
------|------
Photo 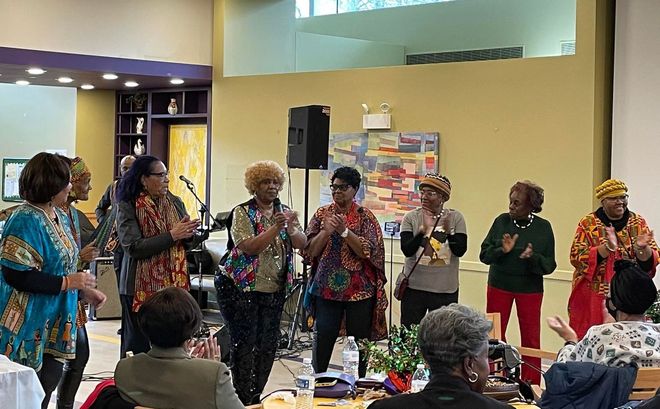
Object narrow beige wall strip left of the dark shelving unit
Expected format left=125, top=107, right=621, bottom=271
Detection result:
left=75, top=90, right=115, bottom=213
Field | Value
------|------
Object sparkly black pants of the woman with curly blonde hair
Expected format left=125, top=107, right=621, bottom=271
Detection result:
left=216, top=277, right=284, bottom=405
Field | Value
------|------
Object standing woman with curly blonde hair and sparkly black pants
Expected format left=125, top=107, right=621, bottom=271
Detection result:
left=215, top=161, right=307, bottom=405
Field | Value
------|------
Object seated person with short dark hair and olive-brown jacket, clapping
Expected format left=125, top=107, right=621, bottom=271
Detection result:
left=115, top=287, right=244, bottom=409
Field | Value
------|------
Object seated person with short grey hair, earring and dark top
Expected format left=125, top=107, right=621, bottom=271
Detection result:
left=369, top=304, right=511, bottom=409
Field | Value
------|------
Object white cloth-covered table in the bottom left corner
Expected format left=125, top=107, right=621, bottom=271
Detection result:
left=0, top=355, right=46, bottom=409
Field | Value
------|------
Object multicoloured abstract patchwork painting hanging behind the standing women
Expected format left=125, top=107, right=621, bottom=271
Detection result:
left=321, top=132, right=440, bottom=233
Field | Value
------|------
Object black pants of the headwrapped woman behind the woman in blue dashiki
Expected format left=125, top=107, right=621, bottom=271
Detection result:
left=57, top=325, right=89, bottom=409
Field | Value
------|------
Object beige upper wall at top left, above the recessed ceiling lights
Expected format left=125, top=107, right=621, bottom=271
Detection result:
left=0, top=0, right=213, bottom=65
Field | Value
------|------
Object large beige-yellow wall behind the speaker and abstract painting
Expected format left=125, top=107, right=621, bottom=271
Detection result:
left=212, top=0, right=612, bottom=349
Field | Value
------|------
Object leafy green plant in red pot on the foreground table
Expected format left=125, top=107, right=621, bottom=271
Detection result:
left=362, top=325, right=424, bottom=392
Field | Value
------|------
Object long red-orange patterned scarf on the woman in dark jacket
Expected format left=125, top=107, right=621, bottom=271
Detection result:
left=133, top=192, right=190, bottom=311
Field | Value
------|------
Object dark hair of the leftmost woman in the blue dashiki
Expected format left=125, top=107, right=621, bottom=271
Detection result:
left=18, top=152, right=71, bottom=203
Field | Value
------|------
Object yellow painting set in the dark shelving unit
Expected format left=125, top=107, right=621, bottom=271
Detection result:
left=168, top=125, right=206, bottom=219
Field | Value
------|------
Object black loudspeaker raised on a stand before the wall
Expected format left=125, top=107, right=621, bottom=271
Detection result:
left=286, top=105, right=330, bottom=169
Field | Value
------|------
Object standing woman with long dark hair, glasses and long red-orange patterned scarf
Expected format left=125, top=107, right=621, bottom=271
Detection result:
left=117, top=155, right=200, bottom=358
